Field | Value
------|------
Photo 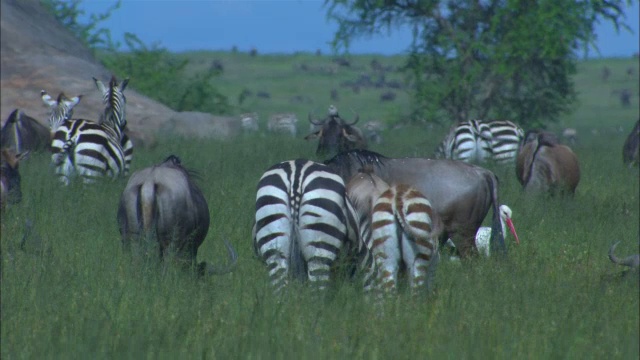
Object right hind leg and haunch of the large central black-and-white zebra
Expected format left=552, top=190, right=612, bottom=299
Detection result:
left=298, top=197, right=348, bottom=289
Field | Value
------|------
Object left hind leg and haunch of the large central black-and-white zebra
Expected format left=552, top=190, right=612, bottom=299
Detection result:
left=254, top=197, right=295, bottom=292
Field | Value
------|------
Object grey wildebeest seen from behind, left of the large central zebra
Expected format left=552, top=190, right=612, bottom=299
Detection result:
left=117, top=155, right=237, bottom=274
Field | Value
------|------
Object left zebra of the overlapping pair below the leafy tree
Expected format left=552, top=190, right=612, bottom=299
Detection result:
left=435, top=120, right=493, bottom=163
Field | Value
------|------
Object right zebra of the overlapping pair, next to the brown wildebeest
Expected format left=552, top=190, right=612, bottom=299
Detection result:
left=487, top=120, right=524, bottom=164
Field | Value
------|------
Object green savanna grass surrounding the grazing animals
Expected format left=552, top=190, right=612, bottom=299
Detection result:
left=0, top=53, right=640, bottom=359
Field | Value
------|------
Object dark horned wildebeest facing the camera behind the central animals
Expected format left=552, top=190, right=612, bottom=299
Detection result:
left=305, top=105, right=367, bottom=155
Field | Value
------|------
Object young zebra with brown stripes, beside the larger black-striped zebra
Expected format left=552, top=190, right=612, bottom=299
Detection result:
left=347, top=172, right=444, bottom=291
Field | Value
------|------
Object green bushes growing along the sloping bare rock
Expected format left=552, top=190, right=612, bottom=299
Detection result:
left=42, top=0, right=231, bottom=114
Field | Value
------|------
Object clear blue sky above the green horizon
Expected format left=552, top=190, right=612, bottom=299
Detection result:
left=81, top=0, right=640, bottom=57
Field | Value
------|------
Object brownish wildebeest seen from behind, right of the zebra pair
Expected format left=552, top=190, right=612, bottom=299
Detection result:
left=516, top=130, right=580, bottom=195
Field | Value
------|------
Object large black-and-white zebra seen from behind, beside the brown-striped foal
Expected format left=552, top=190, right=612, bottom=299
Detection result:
left=253, top=159, right=359, bottom=292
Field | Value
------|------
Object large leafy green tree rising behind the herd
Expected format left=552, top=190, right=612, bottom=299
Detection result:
left=325, top=0, right=631, bottom=127
